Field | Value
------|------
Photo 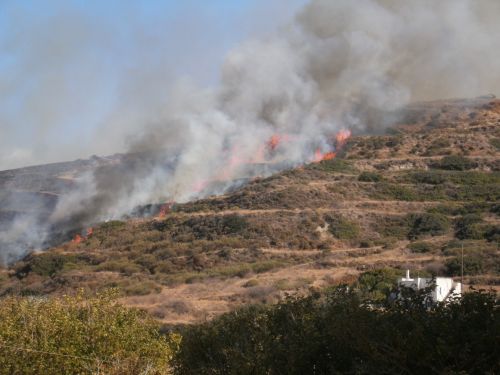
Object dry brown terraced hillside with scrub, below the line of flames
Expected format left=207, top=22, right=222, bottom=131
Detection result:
left=0, top=97, right=500, bottom=324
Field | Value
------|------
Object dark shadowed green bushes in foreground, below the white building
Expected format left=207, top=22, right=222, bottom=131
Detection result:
left=174, top=288, right=500, bottom=375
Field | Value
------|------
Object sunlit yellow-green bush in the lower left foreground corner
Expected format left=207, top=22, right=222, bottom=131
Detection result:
left=0, top=292, right=177, bottom=374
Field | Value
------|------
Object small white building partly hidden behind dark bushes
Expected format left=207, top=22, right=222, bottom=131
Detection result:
left=398, top=270, right=462, bottom=302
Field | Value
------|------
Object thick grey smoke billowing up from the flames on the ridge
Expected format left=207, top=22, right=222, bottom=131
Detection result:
left=0, top=0, right=500, bottom=262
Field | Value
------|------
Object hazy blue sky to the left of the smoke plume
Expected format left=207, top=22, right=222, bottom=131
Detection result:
left=0, top=0, right=306, bottom=170
